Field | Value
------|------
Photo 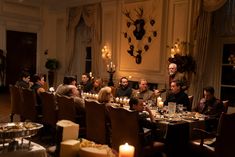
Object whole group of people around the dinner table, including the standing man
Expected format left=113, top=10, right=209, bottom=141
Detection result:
left=13, top=63, right=224, bottom=140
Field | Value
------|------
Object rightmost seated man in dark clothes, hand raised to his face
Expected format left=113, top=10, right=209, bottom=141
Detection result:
left=193, top=87, right=224, bottom=118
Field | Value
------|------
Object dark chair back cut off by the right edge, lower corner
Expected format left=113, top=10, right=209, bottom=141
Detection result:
left=215, top=113, right=235, bottom=157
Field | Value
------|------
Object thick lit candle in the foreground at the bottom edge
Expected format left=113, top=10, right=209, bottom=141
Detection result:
left=119, top=143, right=135, bottom=157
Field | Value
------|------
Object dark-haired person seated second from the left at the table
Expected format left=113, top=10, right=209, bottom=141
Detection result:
left=31, top=74, right=46, bottom=114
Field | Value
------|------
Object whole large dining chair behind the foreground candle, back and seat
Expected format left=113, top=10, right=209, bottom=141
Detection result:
left=108, top=106, right=164, bottom=157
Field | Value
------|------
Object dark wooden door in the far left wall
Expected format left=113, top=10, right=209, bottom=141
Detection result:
left=6, top=30, right=37, bottom=86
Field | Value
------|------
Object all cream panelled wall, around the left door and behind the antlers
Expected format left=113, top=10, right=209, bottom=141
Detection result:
left=0, top=0, right=193, bottom=87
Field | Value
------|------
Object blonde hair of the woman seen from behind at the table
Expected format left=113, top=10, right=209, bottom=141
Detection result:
left=98, top=86, right=112, bottom=103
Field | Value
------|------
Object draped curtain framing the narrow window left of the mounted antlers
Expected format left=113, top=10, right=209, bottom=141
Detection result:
left=65, top=4, right=101, bottom=74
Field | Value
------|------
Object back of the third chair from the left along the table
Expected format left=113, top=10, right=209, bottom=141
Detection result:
left=41, top=92, right=57, bottom=127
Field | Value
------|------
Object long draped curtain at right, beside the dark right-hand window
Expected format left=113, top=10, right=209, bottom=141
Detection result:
left=191, top=0, right=226, bottom=106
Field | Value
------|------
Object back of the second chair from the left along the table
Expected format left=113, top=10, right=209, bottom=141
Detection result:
left=20, top=88, right=38, bottom=122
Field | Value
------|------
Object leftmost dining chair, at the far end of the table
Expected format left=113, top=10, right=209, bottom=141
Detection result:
left=9, top=84, right=22, bottom=122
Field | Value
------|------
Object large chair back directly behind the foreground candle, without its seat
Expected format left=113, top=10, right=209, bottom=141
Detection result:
left=109, top=106, right=141, bottom=156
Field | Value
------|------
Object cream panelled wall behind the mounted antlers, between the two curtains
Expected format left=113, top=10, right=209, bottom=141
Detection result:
left=102, top=0, right=191, bottom=88
